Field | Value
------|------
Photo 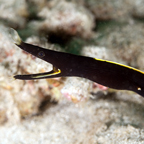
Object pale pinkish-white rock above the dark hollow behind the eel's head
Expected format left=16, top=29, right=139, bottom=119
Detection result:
left=39, top=1, right=94, bottom=41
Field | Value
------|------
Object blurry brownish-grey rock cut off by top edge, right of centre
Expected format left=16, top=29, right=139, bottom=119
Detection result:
left=83, top=0, right=135, bottom=21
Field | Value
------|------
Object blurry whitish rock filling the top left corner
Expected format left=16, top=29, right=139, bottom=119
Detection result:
left=0, top=0, right=28, bottom=28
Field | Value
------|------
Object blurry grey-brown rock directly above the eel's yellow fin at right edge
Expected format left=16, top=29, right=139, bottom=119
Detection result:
left=96, top=20, right=144, bottom=70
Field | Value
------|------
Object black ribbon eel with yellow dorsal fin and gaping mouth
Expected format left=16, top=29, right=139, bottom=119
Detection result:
left=11, top=29, right=144, bottom=97
